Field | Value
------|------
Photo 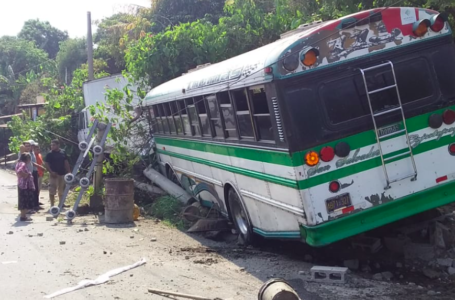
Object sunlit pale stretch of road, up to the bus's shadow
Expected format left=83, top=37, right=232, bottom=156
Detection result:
left=0, top=170, right=261, bottom=300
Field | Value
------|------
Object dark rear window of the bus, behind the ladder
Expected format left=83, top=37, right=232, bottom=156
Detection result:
left=319, top=58, right=433, bottom=124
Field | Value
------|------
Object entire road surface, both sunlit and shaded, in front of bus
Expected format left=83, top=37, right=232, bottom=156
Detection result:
left=0, top=170, right=455, bottom=300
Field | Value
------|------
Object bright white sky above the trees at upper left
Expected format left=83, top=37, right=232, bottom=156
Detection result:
left=0, top=0, right=150, bottom=38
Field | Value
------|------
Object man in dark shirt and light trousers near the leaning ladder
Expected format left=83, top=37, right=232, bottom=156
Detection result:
left=44, top=140, right=71, bottom=206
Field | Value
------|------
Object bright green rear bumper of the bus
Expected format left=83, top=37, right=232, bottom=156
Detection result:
left=300, top=182, right=455, bottom=247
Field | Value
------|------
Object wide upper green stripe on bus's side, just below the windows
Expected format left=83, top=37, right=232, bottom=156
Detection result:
left=155, top=137, right=292, bottom=167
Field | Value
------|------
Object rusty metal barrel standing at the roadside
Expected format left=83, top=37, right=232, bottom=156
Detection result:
left=104, top=178, right=134, bottom=224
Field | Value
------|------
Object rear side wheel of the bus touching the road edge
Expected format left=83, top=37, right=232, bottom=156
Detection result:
left=228, top=188, right=256, bottom=246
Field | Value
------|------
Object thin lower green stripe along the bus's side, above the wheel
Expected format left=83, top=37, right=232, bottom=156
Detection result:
left=157, top=149, right=297, bottom=189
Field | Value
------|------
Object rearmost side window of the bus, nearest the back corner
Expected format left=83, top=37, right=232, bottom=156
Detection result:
left=250, top=86, right=275, bottom=141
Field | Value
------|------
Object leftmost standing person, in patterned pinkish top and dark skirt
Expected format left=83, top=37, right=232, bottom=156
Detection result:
left=16, top=152, right=35, bottom=222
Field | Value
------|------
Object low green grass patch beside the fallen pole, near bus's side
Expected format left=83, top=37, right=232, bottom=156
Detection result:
left=147, top=196, right=186, bottom=229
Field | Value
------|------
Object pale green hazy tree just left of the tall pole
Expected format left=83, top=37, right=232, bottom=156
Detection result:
left=56, top=38, right=87, bottom=83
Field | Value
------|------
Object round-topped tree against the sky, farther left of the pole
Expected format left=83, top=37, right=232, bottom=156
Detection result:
left=18, top=19, right=68, bottom=59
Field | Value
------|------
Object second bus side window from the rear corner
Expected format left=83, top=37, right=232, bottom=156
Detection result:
left=232, top=89, right=254, bottom=139
